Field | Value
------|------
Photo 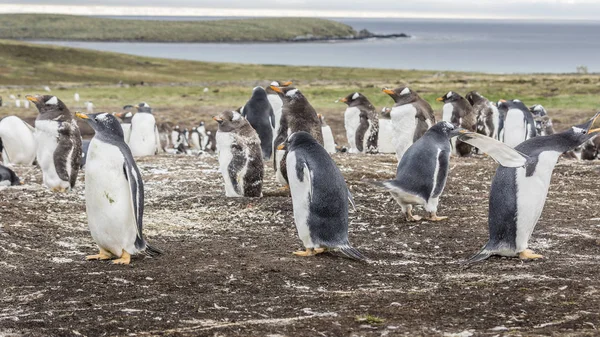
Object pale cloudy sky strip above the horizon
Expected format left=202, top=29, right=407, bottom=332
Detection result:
left=0, top=0, right=600, bottom=21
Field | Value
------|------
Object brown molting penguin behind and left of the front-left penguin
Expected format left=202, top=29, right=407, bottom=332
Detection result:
left=26, top=95, right=81, bottom=192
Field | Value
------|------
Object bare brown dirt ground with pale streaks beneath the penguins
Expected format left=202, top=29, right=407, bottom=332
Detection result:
left=0, top=111, right=600, bottom=336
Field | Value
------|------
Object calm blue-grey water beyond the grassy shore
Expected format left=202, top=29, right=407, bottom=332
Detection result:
left=30, top=17, right=600, bottom=73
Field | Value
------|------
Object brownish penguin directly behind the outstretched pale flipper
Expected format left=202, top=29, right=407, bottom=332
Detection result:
left=436, top=91, right=477, bottom=157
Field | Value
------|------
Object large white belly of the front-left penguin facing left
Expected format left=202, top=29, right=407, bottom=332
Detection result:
left=85, top=138, right=138, bottom=257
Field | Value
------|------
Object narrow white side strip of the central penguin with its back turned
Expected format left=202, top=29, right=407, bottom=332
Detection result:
left=286, top=151, right=315, bottom=248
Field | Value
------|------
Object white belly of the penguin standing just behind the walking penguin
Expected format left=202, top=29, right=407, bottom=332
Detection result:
left=390, top=104, right=417, bottom=162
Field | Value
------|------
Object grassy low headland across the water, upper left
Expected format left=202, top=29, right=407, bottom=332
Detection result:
left=0, top=14, right=356, bottom=42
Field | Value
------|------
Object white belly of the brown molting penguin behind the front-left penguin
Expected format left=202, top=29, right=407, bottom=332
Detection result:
left=35, top=120, right=71, bottom=189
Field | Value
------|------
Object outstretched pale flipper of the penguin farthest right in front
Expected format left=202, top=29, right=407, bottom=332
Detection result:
left=458, top=131, right=529, bottom=167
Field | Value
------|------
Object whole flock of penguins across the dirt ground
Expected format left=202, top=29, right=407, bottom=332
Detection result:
left=0, top=81, right=600, bottom=264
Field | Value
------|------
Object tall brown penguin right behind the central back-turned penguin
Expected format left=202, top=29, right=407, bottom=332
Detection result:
left=272, top=86, right=323, bottom=186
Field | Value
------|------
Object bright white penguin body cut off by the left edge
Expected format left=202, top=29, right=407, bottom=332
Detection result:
left=0, top=115, right=37, bottom=165
